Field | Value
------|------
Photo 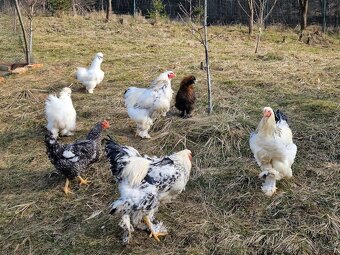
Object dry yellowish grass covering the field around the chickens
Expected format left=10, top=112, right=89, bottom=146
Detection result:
left=0, top=12, right=340, bottom=255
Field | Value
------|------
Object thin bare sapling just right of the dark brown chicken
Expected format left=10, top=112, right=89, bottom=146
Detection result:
left=179, top=0, right=213, bottom=114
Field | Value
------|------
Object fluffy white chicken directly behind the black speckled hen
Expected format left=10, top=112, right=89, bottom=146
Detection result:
left=45, top=87, right=77, bottom=138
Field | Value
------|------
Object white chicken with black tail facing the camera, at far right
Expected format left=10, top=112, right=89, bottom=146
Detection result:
left=249, top=107, right=297, bottom=196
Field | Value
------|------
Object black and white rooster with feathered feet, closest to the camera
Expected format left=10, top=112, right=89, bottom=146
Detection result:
left=105, top=138, right=192, bottom=243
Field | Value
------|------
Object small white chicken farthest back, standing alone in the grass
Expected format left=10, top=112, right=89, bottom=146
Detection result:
left=76, top=52, right=104, bottom=93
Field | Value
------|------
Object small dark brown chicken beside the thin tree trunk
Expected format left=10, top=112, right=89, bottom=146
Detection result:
left=175, top=75, right=196, bottom=118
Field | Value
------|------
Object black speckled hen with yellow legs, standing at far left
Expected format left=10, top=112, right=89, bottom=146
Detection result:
left=45, top=120, right=110, bottom=194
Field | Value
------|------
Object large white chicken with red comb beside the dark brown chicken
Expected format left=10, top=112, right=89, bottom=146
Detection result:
left=124, top=71, right=176, bottom=138
